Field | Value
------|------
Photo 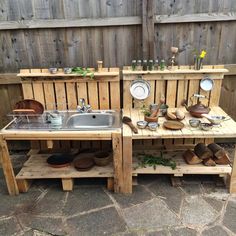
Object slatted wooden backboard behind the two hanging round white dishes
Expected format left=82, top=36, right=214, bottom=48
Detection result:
left=122, top=66, right=227, bottom=146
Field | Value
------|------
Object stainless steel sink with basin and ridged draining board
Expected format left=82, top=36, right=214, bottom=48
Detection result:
left=7, top=110, right=121, bottom=131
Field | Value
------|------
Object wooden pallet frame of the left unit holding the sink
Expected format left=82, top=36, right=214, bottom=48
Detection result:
left=0, top=68, right=123, bottom=195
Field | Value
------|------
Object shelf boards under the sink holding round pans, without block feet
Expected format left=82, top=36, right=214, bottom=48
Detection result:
left=16, top=154, right=114, bottom=179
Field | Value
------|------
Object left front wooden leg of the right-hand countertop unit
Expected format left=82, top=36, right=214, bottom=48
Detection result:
left=122, top=136, right=133, bottom=193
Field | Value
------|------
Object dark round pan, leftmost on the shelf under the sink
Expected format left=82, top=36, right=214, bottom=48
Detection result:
left=47, top=153, right=73, bottom=168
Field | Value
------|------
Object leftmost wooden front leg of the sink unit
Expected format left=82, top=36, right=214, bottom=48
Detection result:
left=0, top=136, right=19, bottom=195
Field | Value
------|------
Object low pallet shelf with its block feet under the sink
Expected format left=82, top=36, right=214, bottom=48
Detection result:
left=16, top=154, right=114, bottom=192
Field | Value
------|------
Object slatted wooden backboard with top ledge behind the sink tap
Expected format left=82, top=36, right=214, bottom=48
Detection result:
left=18, top=68, right=121, bottom=150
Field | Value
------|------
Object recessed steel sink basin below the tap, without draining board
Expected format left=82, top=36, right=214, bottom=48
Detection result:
left=66, top=112, right=115, bottom=129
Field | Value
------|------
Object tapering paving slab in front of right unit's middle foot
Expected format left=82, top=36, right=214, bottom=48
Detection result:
left=148, top=181, right=184, bottom=214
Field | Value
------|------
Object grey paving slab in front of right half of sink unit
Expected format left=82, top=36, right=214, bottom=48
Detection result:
left=62, top=186, right=113, bottom=216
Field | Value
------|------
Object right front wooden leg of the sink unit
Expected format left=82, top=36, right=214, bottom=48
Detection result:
left=112, top=133, right=123, bottom=193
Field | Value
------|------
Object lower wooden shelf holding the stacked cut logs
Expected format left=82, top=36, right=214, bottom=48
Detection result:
left=133, top=151, right=232, bottom=176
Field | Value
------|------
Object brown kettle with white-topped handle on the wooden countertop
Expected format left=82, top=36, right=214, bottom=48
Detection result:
left=182, top=94, right=211, bottom=118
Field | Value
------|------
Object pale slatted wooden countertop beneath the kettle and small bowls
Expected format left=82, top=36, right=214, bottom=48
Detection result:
left=123, top=107, right=236, bottom=139
